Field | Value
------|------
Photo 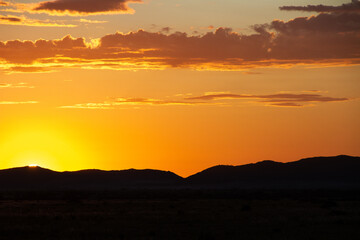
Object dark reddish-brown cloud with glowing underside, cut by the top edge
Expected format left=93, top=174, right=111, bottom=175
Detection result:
left=31, top=0, right=142, bottom=15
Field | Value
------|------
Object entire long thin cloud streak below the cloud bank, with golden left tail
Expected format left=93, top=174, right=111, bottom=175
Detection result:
left=59, top=92, right=350, bottom=109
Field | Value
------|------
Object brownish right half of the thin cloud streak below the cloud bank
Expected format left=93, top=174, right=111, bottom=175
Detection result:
left=185, top=93, right=350, bottom=107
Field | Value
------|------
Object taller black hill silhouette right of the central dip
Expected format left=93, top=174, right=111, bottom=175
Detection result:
left=186, top=155, right=360, bottom=188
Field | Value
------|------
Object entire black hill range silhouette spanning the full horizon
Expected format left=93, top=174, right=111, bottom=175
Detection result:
left=0, top=155, right=360, bottom=190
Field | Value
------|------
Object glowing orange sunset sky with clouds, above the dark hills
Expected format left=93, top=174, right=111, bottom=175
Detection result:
left=0, top=0, right=360, bottom=177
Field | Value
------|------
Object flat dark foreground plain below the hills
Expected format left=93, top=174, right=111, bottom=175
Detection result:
left=0, top=189, right=360, bottom=240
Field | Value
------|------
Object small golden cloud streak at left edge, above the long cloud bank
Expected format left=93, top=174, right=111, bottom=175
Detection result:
left=0, top=15, right=76, bottom=27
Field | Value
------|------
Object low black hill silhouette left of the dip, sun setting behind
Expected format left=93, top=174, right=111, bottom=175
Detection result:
left=0, top=167, right=183, bottom=190
